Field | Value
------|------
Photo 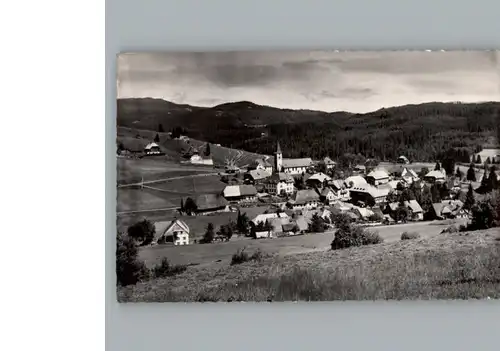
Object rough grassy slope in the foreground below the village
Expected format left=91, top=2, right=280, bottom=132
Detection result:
left=118, top=229, right=500, bottom=302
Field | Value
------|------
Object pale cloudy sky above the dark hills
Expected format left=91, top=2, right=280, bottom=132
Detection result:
left=117, top=51, right=500, bottom=113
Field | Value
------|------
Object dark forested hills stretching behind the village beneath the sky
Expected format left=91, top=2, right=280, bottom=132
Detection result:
left=117, top=99, right=500, bottom=161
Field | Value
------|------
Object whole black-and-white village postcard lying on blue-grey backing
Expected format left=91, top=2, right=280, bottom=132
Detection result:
left=114, top=50, right=500, bottom=303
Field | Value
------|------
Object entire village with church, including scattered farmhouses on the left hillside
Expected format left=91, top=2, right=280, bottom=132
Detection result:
left=118, top=136, right=500, bottom=250
